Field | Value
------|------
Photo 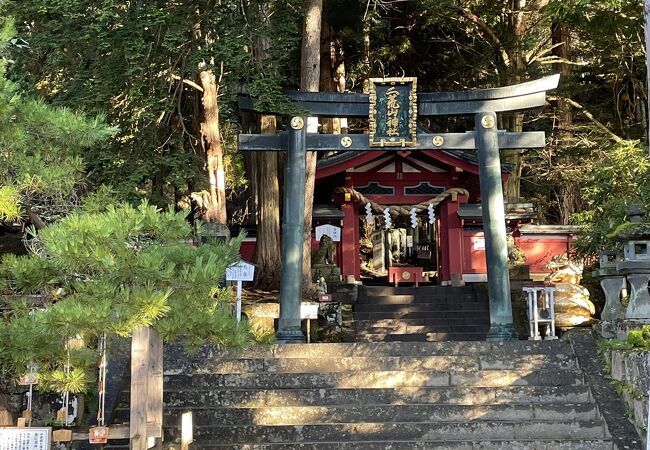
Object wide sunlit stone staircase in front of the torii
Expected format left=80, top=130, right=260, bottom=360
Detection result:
left=134, top=341, right=615, bottom=450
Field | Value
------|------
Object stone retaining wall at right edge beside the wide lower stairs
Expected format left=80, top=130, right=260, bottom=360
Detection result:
left=605, top=350, right=650, bottom=440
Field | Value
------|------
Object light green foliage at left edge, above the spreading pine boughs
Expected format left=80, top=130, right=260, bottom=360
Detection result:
left=0, top=21, right=115, bottom=225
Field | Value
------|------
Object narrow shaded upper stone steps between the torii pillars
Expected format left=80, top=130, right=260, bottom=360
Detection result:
left=353, top=285, right=490, bottom=342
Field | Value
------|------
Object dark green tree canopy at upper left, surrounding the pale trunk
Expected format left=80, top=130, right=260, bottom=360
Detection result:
left=0, top=0, right=302, bottom=205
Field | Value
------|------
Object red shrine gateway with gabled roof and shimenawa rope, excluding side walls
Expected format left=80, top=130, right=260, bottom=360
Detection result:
left=314, top=142, right=508, bottom=285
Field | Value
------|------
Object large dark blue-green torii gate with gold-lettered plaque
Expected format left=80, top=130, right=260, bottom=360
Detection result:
left=239, top=75, right=559, bottom=343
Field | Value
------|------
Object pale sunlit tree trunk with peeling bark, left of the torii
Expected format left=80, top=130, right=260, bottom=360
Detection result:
left=199, top=66, right=226, bottom=224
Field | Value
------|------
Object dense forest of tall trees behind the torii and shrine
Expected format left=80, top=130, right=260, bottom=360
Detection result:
left=0, top=0, right=650, bottom=288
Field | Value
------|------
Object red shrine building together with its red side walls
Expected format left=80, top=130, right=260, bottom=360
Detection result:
left=242, top=149, right=576, bottom=284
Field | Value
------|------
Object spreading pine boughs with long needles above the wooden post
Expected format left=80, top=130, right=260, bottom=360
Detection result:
left=0, top=200, right=267, bottom=392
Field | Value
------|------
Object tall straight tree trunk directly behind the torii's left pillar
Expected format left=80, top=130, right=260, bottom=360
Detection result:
left=300, top=0, right=323, bottom=297
